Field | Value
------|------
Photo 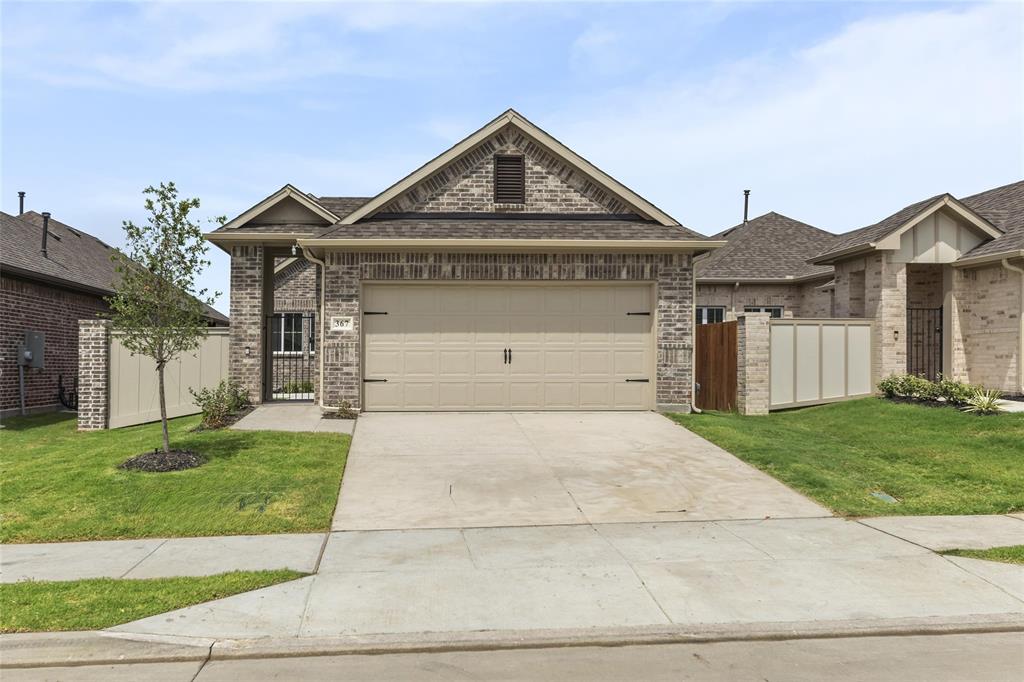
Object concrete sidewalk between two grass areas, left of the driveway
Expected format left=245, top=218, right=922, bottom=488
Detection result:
left=0, top=532, right=326, bottom=583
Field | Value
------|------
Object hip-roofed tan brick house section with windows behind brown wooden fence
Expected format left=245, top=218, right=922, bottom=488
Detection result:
left=695, top=212, right=837, bottom=325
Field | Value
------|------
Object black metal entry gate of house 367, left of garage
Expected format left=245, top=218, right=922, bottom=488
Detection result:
left=263, top=312, right=316, bottom=400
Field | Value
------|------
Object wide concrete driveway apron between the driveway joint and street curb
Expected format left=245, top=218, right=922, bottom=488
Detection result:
left=113, top=518, right=1024, bottom=639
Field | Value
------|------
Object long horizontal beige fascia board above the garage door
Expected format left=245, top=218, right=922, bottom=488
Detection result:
left=298, top=239, right=725, bottom=253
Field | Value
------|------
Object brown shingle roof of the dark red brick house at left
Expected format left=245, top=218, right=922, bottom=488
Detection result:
left=0, top=211, right=227, bottom=323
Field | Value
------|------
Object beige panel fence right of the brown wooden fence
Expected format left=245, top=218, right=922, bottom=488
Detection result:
left=769, top=319, right=873, bottom=410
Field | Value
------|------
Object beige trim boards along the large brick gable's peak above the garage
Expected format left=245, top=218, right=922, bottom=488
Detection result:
left=341, top=109, right=679, bottom=225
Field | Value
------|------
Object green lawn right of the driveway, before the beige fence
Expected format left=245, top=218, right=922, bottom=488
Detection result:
left=670, top=398, right=1024, bottom=516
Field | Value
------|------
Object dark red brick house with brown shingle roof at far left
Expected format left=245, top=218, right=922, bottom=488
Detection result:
left=0, top=202, right=227, bottom=416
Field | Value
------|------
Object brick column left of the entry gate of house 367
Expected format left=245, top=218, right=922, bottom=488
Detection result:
left=228, top=246, right=264, bottom=402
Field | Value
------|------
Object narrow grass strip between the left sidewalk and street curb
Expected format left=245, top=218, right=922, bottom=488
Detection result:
left=0, top=569, right=304, bottom=632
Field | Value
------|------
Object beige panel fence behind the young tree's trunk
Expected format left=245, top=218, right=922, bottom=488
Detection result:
left=108, top=328, right=228, bottom=429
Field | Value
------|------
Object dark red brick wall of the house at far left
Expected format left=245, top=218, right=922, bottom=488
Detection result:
left=0, top=275, right=109, bottom=414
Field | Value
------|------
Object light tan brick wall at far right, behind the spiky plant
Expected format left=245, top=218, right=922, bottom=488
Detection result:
left=950, top=265, right=1022, bottom=393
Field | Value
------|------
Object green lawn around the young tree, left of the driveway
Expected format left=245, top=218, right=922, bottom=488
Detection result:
left=0, top=414, right=349, bottom=543
